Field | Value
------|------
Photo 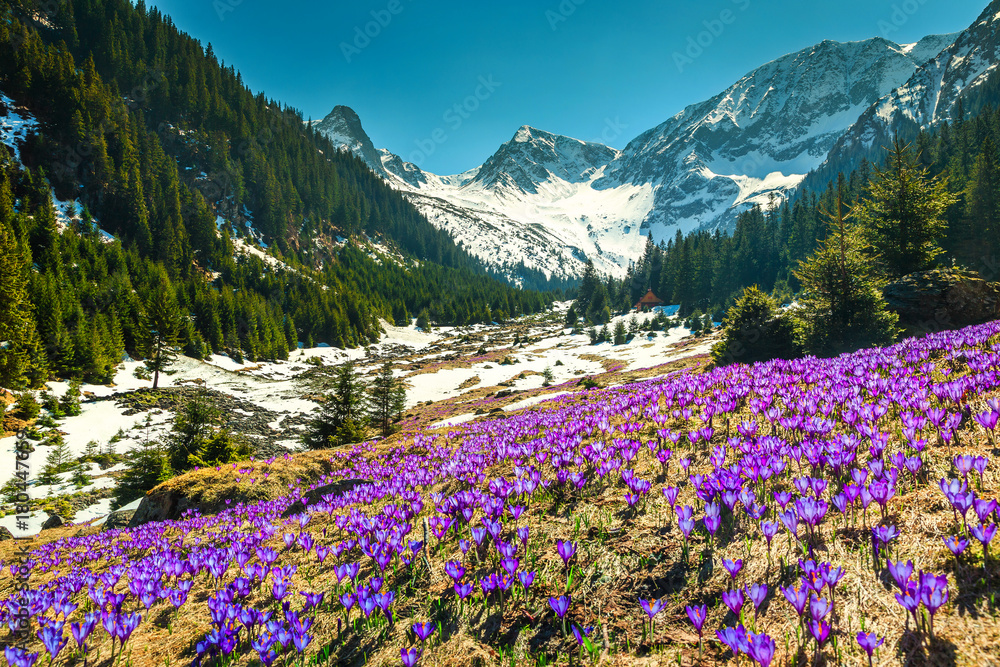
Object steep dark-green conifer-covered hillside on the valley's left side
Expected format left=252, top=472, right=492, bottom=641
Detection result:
left=0, top=0, right=552, bottom=386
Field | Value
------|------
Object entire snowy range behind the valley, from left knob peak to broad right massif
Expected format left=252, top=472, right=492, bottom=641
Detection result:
left=317, top=33, right=960, bottom=280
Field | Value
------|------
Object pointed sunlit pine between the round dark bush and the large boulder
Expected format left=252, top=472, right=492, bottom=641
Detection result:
left=795, top=193, right=899, bottom=356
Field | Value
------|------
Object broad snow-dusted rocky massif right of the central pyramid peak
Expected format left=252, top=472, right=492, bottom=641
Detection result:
left=597, top=35, right=954, bottom=238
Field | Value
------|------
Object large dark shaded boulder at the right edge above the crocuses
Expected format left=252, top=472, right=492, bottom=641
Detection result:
left=882, top=269, right=1000, bottom=332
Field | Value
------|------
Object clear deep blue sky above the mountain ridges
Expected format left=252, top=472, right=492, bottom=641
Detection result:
left=151, top=0, right=987, bottom=174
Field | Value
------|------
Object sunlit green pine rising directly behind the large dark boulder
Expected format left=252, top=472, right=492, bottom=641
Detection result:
left=855, top=138, right=955, bottom=277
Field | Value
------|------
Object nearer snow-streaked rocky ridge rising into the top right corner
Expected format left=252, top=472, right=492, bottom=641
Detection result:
left=830, top=0, right=1000, bottom=164
